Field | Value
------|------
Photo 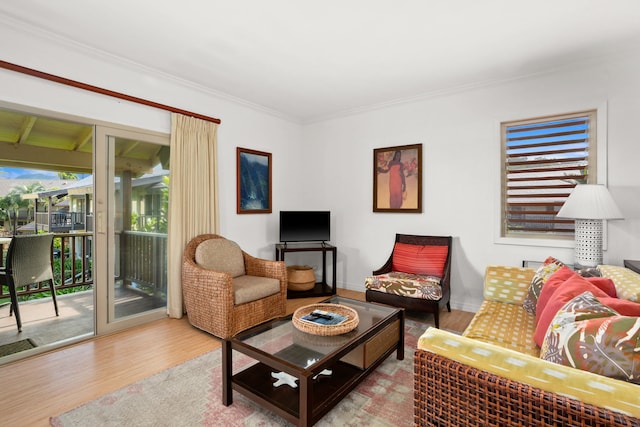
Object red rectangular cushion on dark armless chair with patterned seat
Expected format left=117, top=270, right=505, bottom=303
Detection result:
left=391, top=243, right=449, bottom=277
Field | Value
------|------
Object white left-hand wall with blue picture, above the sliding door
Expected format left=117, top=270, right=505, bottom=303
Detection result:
left=0, top=26, right=304, bottom=268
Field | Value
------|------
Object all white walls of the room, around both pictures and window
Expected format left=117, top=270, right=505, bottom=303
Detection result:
left=0, top=22, right=640, bottom=310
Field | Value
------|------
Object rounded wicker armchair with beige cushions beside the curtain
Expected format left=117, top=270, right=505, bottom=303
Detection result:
left=182, top=234, right=287, bottom=338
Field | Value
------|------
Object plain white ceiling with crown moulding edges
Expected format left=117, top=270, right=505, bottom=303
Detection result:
left=0, top=0, right=640, bottom=121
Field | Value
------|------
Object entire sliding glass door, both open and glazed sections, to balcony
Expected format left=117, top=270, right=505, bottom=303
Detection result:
left=0, top=104, right=169, bottom=363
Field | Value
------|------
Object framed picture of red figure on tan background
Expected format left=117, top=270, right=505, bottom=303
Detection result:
left=373, top=144, right=422, bottom=213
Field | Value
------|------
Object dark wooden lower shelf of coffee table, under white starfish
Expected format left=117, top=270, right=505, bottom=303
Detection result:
left=232, top=362, right=368, bottom=424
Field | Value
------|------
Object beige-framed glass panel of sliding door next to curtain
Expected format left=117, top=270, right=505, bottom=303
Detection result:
left=95, top=126, right=169, bottom=334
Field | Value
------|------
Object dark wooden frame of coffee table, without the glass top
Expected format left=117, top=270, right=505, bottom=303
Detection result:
left=222, top=297, right=404, bottom=426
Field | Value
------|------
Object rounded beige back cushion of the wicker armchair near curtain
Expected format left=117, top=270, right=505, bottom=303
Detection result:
left=195, top=239, right=245, bottom=277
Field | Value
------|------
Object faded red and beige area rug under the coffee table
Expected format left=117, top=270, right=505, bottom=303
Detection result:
left=50, top=320, right=429, bottom=427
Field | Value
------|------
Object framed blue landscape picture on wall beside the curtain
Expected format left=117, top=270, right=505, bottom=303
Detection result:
left=236, top=147, right=272, bottom=214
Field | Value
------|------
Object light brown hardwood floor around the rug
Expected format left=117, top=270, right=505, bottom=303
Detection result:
left=0, top=290, right=473, bottom=427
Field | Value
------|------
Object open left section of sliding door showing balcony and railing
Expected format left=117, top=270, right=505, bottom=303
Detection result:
left=0, top=108, right=97, bottom=363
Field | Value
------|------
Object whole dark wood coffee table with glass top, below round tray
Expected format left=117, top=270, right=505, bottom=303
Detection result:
left=222, top=296, right=404, bottom=426
